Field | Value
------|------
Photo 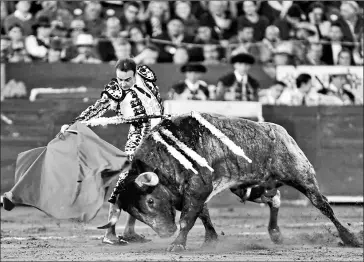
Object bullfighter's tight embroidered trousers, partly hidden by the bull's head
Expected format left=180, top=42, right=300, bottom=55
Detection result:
left=108, top=120, right=150, bottom=204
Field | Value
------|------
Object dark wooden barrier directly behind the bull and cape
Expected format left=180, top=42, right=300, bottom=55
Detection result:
left=1, top=99, right=363, bottom=202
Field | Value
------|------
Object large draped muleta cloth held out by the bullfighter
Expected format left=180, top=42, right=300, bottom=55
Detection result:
left=4, top=123, right=130, bottom=222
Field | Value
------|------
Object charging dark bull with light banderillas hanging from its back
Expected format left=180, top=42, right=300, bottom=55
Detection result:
left=97, top=114, right=362, bottom=251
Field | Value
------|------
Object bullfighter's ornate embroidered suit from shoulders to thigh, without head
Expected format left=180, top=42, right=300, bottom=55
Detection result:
left=72, top=65, right=164, bottom=155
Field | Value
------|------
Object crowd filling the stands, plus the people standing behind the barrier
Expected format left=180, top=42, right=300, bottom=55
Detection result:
left=0, top=0, right=364, bottom=105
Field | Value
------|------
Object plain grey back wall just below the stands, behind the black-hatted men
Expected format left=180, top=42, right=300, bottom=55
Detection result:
left=5, top=63, right=273, bottom=99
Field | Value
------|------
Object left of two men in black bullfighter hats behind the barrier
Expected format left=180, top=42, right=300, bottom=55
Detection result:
left=168, top=63, right=209, bottom=100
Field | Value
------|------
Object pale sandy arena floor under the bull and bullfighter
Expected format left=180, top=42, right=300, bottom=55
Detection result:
left=1, top=203, right=363, bottom=261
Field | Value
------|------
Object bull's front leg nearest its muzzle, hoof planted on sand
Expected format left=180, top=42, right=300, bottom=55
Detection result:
left=167, top=197, right=204, bottom=252
